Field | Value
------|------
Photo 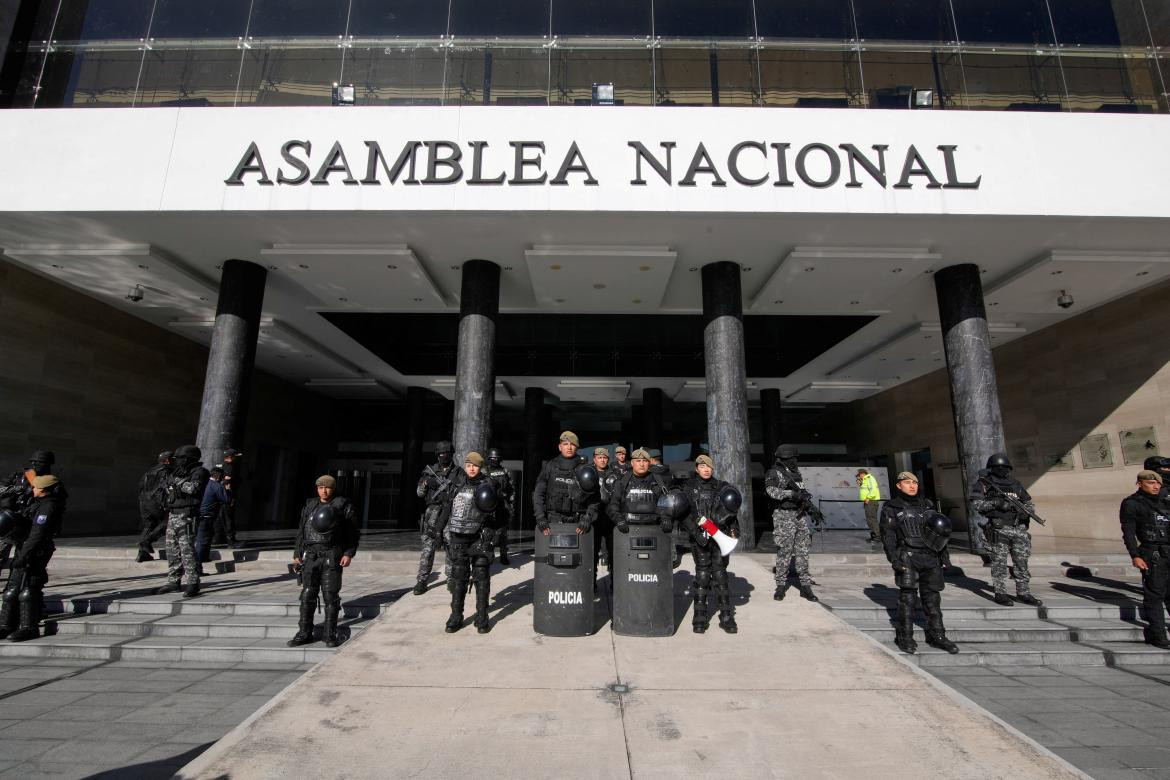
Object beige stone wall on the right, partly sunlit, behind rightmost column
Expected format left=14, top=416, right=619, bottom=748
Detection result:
left=849, top=277, right=1170, bottom=544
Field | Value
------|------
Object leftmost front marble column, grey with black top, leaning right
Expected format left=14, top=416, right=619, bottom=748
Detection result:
left=195, top=260, right=268, bottom=468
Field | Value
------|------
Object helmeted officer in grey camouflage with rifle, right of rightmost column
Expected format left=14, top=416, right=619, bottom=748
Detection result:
left=971, top=453, right=1042, bottom=607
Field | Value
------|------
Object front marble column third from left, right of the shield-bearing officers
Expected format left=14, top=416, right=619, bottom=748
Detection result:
left=702, top=261, right=756, bottom=550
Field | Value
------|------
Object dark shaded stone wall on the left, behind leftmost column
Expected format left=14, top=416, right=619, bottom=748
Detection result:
left=0, top=261, right=332, bottom=536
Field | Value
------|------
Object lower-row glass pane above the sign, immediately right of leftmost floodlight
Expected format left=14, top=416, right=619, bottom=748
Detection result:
left=345, top=47, right=446, bottom=105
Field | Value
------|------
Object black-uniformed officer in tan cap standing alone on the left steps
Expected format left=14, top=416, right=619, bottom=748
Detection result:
left=288, top=474, right=362, bottom=648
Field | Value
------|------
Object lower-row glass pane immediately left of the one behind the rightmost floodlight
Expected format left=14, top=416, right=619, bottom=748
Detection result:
left=758, top=49, right=865, bottom=109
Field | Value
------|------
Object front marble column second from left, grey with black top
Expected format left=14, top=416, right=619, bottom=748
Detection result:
left=453, top=260, right=500, bottom=465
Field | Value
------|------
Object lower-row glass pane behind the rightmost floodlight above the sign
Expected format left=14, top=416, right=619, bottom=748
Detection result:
left=861, top=50, right=962, bottom=109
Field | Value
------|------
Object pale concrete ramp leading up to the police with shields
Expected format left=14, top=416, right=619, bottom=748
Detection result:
left=179, top=558, right=1085, bottom=780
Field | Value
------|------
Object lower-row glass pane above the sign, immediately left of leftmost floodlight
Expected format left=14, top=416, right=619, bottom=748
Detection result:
left=236, top=46, right=342, bottom=105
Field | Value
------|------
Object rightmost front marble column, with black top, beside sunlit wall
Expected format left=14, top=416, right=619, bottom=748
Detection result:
left=935, top=263, right=1005, bottom=548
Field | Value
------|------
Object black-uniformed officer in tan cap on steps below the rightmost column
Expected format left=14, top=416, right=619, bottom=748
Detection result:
left=879, top=471, right=958, bottom=655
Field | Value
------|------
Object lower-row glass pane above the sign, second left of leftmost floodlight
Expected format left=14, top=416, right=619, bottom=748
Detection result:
left=135, top=46, right=243, bottom=105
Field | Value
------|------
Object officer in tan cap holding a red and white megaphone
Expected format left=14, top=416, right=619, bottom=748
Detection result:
left=682, top=455, right=739, bottom=634
